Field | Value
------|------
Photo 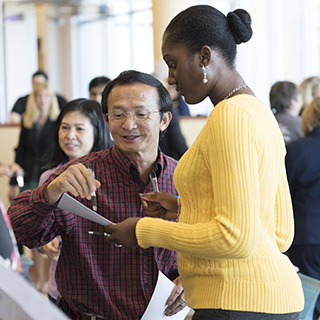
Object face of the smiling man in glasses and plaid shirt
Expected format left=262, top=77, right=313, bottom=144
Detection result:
left=108, top=83, right=171, bottom=161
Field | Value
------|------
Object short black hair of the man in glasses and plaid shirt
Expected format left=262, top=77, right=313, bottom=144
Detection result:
left=101, top=70, right=173, bottom=119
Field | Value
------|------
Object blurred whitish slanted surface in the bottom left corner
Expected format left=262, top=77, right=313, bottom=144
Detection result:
left=0, top=257, right=70, bottom=320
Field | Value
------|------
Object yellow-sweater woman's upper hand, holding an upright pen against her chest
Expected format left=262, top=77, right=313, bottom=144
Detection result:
left=139, top=191, right=178, bottom=220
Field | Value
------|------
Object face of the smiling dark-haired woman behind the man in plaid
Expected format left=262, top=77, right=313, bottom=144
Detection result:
left=58, top=111, right=94, bottom=160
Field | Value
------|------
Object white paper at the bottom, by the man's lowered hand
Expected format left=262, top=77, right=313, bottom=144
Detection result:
left=141, top=271, right=190, bottom=320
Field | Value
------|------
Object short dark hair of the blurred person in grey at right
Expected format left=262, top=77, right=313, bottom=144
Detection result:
left=269, top=81, right=300, bottom=113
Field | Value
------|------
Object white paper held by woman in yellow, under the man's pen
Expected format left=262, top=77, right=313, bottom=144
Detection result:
left=58, top=193, right=113, bottom=226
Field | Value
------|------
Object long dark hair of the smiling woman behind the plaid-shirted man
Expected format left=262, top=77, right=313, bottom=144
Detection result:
left=44, top=98, right=109, bottom=169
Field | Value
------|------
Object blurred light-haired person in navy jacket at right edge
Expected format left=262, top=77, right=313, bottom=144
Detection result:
left=286, top=97, right=320, bottom=320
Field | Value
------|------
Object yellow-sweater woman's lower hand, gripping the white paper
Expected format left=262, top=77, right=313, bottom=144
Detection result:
left=104, top=218, right=140, bottom=248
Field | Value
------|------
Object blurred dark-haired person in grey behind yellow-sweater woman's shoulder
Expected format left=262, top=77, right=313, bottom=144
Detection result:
left=269, top=81, right=303, bottom=145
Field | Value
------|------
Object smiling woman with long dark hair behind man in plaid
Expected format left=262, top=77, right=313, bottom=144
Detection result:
left=39, top=99, right=113, bottom=302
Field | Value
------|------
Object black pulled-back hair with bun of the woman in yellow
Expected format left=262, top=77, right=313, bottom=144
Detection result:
left=164, top=5, right=252, bottom=67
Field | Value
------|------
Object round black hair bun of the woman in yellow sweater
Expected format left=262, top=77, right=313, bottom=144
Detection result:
left=227, top=9, right=253, bottom=44
